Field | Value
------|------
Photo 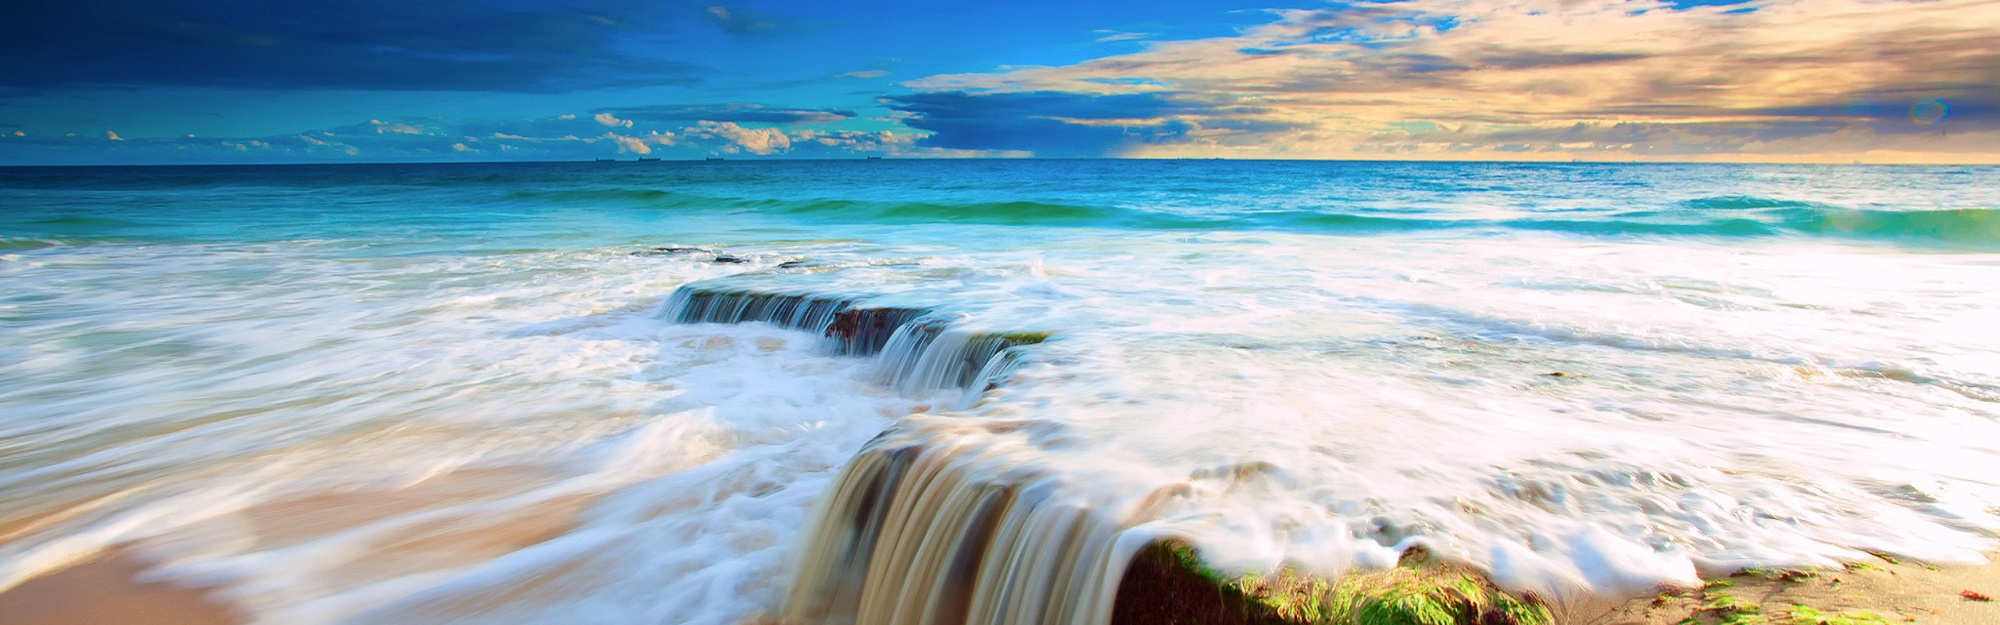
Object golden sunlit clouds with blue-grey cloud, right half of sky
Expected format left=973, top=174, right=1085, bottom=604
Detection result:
left=890, top=0, right=2000, bottom=162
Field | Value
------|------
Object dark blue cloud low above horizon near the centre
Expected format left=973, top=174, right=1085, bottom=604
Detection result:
left=884, top=92, right=1188, bottom=156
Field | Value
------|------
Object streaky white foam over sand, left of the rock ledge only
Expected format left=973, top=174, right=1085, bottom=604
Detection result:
left=0, top=244, right=918, bottom=623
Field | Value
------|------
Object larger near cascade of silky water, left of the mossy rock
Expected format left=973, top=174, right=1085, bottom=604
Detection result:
left=784, top=432, right=1146, bottom=625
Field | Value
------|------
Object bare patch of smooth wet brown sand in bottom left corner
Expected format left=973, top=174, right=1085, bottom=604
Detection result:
left=0, top=549, right=244, bottom=625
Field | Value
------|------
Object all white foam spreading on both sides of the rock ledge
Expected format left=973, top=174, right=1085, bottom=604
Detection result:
left=0, top=228, right=2000, bottom=623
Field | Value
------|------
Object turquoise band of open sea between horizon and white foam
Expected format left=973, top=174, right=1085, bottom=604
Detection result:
left=4, top=160, right=2000, bottom=248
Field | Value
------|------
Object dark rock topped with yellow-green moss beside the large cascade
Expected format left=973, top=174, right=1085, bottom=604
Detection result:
left=1112, top=541, right=1554, bottom=625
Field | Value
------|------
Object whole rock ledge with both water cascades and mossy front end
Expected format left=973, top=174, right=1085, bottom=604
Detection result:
left=666, top=280, right=1548, bottom=625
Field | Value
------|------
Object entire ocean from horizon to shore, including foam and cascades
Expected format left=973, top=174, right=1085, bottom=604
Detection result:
left=0, top=160, right=2000, bottom=625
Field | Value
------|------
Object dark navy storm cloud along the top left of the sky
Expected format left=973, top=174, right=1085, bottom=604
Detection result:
left=0, top=0, right=698, bottom=92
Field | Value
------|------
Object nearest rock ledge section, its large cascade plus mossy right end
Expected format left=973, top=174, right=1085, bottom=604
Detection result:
left=778, top=417, right=1554, bottom=625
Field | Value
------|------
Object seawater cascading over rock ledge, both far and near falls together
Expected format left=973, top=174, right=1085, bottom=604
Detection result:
left=668, top=286, right=1170, bottom=625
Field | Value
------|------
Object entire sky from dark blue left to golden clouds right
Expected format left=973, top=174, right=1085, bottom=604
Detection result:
left=0, top=0, right=2000, bottom=164
